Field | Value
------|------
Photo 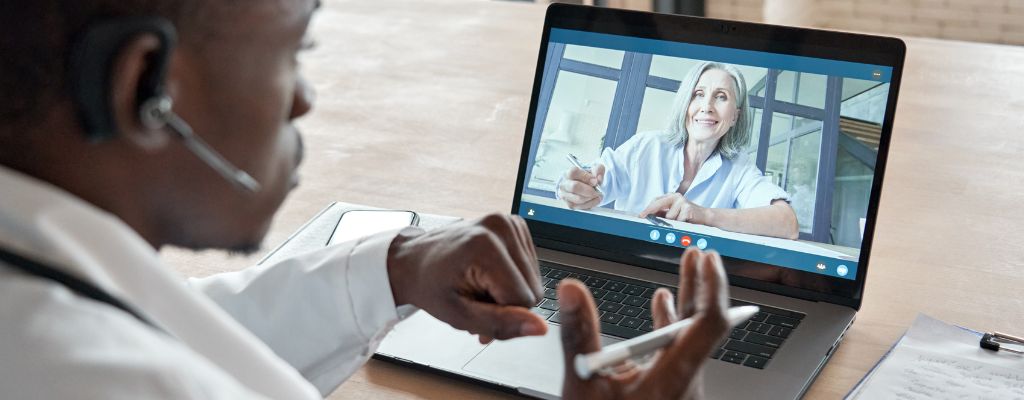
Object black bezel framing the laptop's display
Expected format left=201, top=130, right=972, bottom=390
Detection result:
left=512, top=3, right=906, bottom=309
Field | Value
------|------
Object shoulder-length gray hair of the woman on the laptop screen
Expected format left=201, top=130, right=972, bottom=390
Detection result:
left=662, top=62, right=753, bottom=159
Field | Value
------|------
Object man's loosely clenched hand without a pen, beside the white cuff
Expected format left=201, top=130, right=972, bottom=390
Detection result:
left=387, top=214, right=548, bottom=343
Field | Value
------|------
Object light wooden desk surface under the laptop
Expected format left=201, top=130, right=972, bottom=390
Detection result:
left=163, top=0, right=1024, bottom=399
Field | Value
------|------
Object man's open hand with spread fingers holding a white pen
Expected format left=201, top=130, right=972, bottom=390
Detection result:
left=558, top=248, right=729, bottom=399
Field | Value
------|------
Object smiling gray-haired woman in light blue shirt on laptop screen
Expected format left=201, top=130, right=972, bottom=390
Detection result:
left=556, top=62, right=799, bottom=239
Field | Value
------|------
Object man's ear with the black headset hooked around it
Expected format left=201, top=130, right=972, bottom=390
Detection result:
left=110, top=33, right=170, bottom=151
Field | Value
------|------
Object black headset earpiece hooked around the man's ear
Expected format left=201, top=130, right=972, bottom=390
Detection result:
left=68, top=17, right=176, bottom=142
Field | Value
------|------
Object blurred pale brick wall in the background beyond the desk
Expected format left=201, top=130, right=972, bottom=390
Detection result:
left=707, top=0, right=1024, bottom=45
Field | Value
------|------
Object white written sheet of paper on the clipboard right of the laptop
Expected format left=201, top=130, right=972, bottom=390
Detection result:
left=851, top=315, right=1024, bottom=400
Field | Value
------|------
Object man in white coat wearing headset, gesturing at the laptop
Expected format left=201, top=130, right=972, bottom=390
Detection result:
left=0, top=0, right=726, bottom=399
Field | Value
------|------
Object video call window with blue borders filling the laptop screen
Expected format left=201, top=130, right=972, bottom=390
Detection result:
left=519, top=29, right=892, bottom=279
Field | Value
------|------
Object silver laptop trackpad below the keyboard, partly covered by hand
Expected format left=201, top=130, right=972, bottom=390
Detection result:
left=463, top=325, right=617, bottom=396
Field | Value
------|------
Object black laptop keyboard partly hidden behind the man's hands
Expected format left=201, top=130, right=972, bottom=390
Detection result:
left=531, top=261, right=804, bottom=369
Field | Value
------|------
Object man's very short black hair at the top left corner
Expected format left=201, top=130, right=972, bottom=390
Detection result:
left=0, top=0, right=209, bottom=131
